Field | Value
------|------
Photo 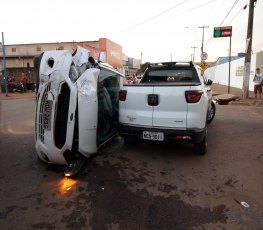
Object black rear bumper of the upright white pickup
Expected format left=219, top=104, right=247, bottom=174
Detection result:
left=119, top=124, right=206, bottom=144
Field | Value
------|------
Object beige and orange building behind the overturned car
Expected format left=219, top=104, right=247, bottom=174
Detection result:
left=0, top=38, right=123, bottom=83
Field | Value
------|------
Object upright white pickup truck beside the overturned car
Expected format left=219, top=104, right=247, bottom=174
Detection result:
left=119, top=62, right=215, bottom=154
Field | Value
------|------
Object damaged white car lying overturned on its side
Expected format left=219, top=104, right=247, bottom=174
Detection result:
left=35, top=47, right=124, bottom=174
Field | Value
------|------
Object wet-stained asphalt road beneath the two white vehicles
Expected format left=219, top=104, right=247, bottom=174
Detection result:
left=0, top=94, right=263, bottom=230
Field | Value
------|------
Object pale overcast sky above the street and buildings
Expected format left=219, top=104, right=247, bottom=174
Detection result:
left=0, top=0, right=263, bottom=63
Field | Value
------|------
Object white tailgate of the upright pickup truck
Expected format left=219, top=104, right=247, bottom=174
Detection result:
left=119, top=85, right=190, bottom=129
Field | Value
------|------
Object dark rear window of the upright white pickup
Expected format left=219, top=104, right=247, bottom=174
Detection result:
left=141, top=67, right=200, bottom=84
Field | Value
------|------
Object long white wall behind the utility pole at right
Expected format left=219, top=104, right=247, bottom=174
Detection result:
left=205, top=54, right=263, bottom=91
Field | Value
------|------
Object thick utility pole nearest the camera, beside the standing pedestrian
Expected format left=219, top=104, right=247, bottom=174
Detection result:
left=243, top=0, right=256, bottom=99
